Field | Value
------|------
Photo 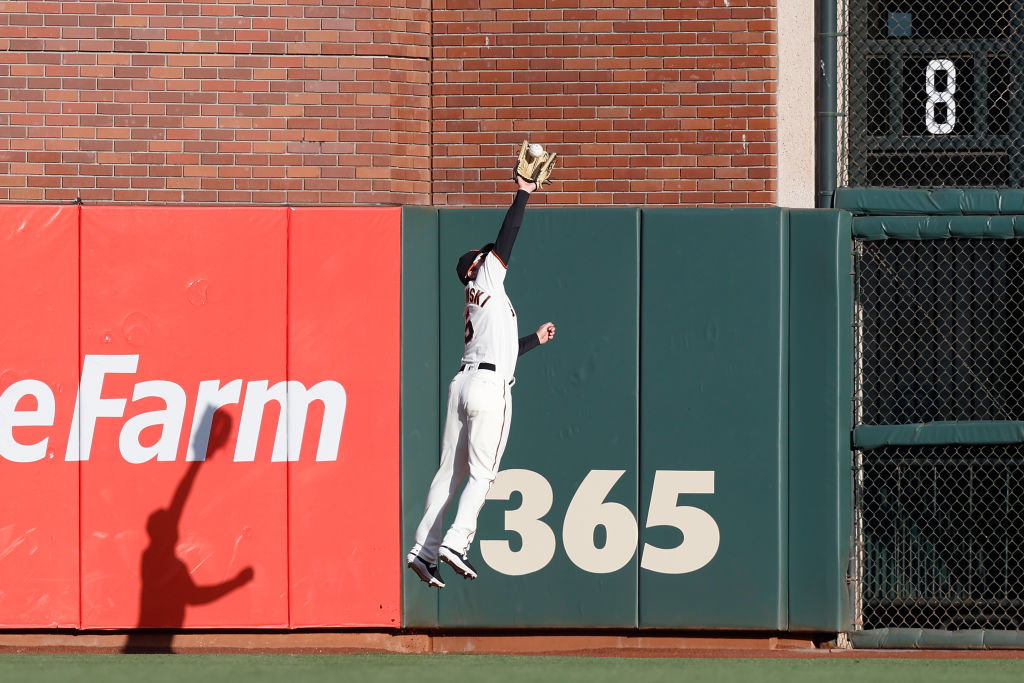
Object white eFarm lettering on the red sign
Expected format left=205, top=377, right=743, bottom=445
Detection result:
left=0, top=354, right=347, bottom=463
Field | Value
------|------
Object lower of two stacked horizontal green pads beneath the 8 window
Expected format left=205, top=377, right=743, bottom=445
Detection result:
left=853, top=215, right=1024, bottom=241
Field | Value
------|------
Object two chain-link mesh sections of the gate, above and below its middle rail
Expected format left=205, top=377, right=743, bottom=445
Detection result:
left=854, top=239, right=1024, bottom=629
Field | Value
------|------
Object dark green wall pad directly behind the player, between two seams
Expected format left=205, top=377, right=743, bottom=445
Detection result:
left=434, top=205, right=639, bottom=627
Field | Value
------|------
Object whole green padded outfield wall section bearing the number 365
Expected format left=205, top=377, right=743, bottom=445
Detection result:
left=399, top=208, right=852, bottom=632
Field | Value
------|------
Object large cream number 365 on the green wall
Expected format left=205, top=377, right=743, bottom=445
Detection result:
left=480, top=470, right=719, bottom=577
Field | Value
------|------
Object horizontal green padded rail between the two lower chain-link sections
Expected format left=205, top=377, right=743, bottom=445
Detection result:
left=853, top=420, right=1024, bottom=451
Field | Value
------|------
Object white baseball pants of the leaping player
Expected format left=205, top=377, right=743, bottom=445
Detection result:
left=413, top=368, right=512, bottom=563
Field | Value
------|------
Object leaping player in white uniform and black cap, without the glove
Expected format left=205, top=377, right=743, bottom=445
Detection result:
left=406, top=175, right=555, bottom=588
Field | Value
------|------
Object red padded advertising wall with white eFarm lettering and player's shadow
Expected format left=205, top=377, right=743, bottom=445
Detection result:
left=0, top=206, right=401, bottom=630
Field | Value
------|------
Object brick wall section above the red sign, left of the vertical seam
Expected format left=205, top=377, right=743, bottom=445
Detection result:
left=0, top=0, right=430, bottom=204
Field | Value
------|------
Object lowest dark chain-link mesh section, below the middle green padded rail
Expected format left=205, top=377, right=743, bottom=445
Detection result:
left=857, top=444, right=1024, bottom=630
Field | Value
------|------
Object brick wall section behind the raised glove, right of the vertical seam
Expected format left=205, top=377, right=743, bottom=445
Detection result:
left=433, top=0, right=774, bottom=206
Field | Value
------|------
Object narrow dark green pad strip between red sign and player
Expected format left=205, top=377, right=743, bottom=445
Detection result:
left=395, top=207, right=440, bottom=627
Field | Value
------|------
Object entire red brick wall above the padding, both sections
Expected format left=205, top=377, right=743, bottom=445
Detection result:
left=0, top=0, right=775, bottom=206
